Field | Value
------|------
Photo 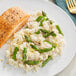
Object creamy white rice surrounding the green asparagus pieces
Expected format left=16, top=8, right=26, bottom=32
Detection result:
left=6, top=11, right=64, bottom=71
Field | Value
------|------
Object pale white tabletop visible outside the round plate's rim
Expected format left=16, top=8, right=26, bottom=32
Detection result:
left=46, top=0, right=76, bottom=76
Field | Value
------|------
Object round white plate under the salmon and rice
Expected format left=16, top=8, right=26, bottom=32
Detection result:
left=0, top=0, right=76, bottom=76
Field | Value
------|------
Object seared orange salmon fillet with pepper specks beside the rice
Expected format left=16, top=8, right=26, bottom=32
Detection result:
left=0, top=7, right=30, bottom=47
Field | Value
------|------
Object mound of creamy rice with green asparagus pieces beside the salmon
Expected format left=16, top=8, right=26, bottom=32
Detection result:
left=7, top=11, right=64, bottom=71
